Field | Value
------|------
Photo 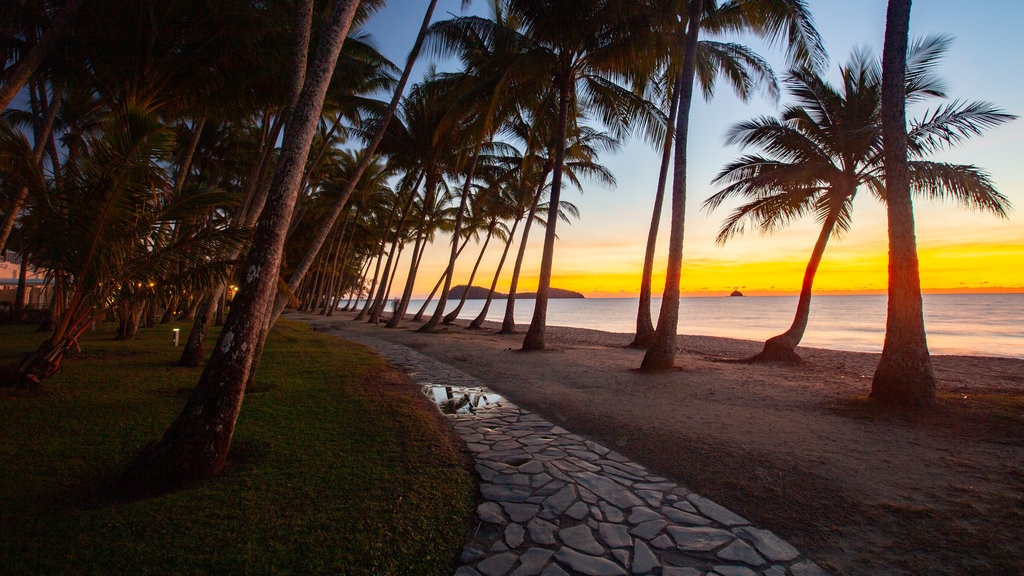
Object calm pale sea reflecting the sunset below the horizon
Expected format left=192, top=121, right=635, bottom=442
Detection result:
left=395, top=294, right=1024, bottom=359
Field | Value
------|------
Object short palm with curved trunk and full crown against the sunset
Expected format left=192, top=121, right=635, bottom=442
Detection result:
left=703, top=42, right=1013, bottom=361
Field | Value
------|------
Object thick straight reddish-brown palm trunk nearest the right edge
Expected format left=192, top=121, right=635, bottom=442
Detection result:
left=870, top=0, right=935, bottom=407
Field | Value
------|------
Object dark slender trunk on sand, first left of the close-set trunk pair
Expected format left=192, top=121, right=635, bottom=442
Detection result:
left=522, top=78, right=569, bottom=352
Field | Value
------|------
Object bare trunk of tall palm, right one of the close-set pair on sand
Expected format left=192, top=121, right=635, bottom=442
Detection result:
left=640, top=0, right=703, bottom=371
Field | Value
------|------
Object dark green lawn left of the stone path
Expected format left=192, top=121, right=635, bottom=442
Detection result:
left=0, top=322, right=472, bottom=575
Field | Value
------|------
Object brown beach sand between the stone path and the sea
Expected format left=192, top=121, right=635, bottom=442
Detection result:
left=292, top=314, right=1024, bottom=575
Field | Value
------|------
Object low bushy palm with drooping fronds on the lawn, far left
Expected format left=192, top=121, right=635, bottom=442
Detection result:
left=8, top=109, right=244, bottom=386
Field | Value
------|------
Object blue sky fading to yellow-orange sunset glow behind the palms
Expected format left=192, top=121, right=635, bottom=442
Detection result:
left=356, top=0, right=1024, bottom=297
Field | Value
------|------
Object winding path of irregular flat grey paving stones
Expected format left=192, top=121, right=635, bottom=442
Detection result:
left=317, top=325, right=827, bottom=576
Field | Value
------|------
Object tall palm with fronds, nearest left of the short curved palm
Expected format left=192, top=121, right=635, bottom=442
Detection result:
left=640, top=0, right=824, bottom=371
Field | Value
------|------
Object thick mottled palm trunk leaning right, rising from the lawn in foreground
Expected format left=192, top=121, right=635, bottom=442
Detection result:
left=128, top=0, right=359, bottom=487
